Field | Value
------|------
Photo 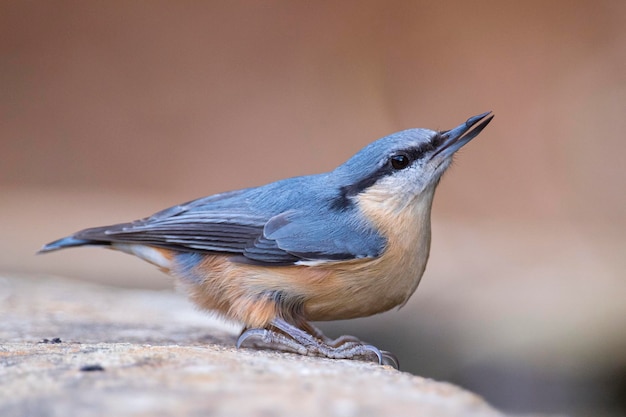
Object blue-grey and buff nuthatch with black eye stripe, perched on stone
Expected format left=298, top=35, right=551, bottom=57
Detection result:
left=38, top=112, right=494, bottom=368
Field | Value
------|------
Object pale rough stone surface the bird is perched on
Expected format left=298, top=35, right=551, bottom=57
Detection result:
left=0, top=276, right=502, bottom=417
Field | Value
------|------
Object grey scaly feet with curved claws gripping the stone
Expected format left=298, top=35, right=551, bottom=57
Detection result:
left=237, top=319, right=399, bottom=369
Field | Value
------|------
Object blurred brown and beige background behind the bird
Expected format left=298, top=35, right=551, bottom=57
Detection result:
left=0, top=0, right=626, bottom=416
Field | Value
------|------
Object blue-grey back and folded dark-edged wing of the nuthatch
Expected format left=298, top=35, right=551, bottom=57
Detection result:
left=72, top=181, right=385, bottom=265
